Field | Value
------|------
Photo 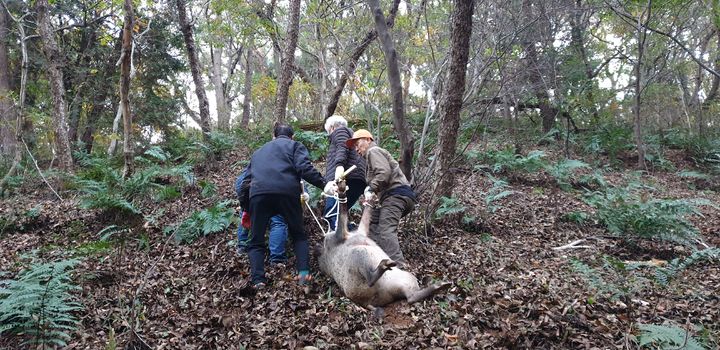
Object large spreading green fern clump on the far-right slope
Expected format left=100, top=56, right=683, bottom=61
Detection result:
left=585, top=183, right=712, bottom=245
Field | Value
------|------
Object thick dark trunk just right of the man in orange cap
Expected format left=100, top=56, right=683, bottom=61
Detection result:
left=435, top=0, right=475, bottom=197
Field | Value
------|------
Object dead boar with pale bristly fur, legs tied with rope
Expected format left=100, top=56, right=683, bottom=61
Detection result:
left=318, top=171, right=450, bottom=309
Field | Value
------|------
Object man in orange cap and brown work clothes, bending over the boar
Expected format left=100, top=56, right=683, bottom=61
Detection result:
left=346, top=129, right=417, bottom=267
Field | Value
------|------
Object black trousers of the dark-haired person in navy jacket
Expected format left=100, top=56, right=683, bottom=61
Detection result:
left=248, top=194, right=310, bottom=284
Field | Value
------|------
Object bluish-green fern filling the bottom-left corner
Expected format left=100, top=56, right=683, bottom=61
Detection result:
left=0, top=259, right=82, bottom=346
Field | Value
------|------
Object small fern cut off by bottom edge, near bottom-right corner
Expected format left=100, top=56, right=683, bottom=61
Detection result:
left=637, top=323, right=705, bottom=350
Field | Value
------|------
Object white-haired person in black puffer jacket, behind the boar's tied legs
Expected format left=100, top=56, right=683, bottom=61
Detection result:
left=324, top=115, right=367, bottom=230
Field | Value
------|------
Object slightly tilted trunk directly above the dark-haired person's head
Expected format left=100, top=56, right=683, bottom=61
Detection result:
left=275, top=0, right=300, bottom=123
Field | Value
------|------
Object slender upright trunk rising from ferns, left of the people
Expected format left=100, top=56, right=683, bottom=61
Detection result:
left=120, top=0, right=135, bottom=178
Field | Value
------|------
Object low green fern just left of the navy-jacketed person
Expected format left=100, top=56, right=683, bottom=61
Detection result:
left=165, top=201, right=237, bottom=243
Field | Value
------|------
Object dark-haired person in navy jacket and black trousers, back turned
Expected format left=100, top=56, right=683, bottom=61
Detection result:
left=241, top=124, right=325, bottom=287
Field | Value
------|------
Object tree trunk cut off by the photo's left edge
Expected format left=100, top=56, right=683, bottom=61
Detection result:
left=0, top=7, right=13, bottom=158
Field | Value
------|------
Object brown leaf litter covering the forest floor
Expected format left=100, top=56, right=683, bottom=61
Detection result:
left=0, top=144, right=720, bottom=349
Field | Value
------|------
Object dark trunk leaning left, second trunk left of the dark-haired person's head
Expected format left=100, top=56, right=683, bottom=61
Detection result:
left=175, top=0, right=210, bottom=136
